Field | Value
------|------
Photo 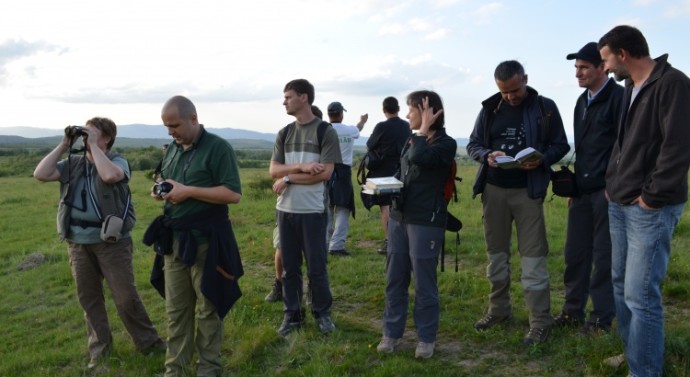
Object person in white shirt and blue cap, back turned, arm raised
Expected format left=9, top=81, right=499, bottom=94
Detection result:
left=326, top=102, right=369, bottom=256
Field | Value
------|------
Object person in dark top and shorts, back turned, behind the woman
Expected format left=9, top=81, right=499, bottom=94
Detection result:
left=362, top=97, right=412, bottom=255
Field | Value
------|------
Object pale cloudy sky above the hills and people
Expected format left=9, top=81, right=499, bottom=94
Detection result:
left=0, top=0, right=690, bottom=138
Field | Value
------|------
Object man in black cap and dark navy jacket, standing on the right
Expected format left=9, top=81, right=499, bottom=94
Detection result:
left=554, top=42, right=623, bottom=334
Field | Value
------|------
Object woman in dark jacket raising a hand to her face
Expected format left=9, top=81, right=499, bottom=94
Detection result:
left=377, top=91, right=457, bottom=359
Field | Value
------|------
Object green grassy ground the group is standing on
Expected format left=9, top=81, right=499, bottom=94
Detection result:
left=0, top=165, right=690, bottom=377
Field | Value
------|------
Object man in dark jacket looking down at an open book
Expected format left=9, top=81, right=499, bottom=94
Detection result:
left=467, top=60, right=570, bottom=345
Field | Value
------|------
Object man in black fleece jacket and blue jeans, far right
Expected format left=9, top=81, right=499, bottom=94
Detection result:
left=599, top=26, right=690, bottom=376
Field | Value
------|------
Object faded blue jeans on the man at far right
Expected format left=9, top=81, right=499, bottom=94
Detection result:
left=609, top=203, right=685, bottom=376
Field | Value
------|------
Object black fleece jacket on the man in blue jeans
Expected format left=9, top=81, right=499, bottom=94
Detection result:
left=606, top=54, right=690, bottom=208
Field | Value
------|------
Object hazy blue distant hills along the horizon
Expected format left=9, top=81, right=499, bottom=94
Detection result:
left=0, top=124, right=467, bottom=150
